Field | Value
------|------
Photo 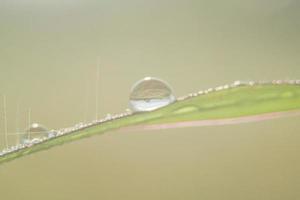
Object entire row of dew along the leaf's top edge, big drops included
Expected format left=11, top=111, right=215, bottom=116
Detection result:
left=0, top=77, right=300, bottom=156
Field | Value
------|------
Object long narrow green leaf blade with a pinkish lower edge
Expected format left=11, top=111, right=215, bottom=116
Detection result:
left=0, top=84, right=300, bottom=164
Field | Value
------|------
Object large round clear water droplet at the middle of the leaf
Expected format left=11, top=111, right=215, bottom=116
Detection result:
left=129, top=77, right=175, bottom=112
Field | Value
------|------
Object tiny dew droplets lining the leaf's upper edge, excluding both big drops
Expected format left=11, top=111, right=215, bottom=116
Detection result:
left=0, top=80, right=300, bottom=156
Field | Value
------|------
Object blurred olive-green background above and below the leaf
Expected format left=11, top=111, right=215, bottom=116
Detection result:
left=0, top=0, right=300, bottom=200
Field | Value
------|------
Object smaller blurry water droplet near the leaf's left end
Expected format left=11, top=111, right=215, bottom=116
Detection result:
left=20, top=123, right=49, bottom=143
